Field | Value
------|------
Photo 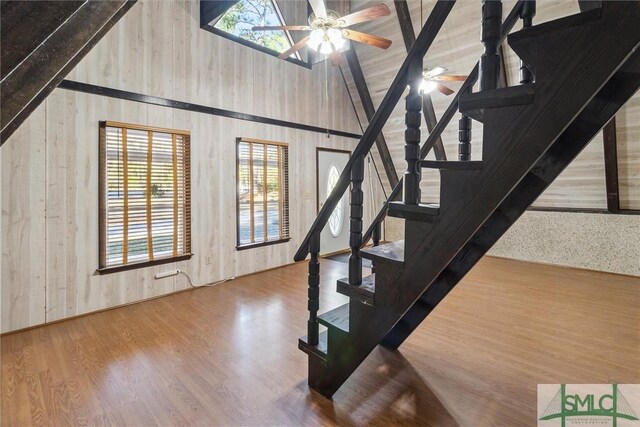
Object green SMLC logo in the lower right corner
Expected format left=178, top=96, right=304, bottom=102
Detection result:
left=540, top=384, right=638, bottom=427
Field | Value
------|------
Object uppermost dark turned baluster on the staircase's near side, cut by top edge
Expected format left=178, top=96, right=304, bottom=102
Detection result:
left=479, top=0, right=502, bottom=91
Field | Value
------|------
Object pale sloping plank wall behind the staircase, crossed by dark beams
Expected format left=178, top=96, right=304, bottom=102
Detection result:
left=348, top=0, right=640, bottom=209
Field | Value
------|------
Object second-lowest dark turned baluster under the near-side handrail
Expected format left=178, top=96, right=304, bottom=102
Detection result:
left=349, top=155, right=364, bottom=286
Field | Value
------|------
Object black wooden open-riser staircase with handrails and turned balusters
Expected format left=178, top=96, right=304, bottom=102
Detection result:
left=295, top=1, right=640, bottom=397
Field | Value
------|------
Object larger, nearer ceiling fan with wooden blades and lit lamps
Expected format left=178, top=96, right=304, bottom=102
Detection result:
left=253, top=0, right=391, bottom=65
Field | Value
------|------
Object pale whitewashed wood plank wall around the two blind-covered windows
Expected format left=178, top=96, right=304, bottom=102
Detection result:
left=0, top=0, right=381, bottom=332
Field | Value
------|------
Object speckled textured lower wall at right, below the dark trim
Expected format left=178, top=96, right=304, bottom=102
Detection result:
left=489, top=211, right=640, bottom=278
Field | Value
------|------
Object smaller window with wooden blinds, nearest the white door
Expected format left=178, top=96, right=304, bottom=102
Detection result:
left=237, top=138, right=289, bottom=249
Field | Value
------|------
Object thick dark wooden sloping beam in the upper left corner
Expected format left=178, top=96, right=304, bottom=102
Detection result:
left=0, top=0, right=136, bottom=146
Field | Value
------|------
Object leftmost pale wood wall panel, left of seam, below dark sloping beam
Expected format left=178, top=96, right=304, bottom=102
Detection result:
left=0, top=105, right=46, bottom=330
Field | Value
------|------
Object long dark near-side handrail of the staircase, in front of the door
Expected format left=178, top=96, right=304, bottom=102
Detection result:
left=294, top=0, right=455, bottom=261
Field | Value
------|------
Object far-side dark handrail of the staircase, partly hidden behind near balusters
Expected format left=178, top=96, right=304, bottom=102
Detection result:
left=360, top=0, right=527, bottom=247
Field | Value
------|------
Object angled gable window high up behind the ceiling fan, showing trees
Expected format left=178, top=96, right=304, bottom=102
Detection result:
left=214, top=0, right=301, bottom=59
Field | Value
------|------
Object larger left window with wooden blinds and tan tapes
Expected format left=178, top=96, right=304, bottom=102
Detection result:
left=100, top=122, right=191, bottom=271
